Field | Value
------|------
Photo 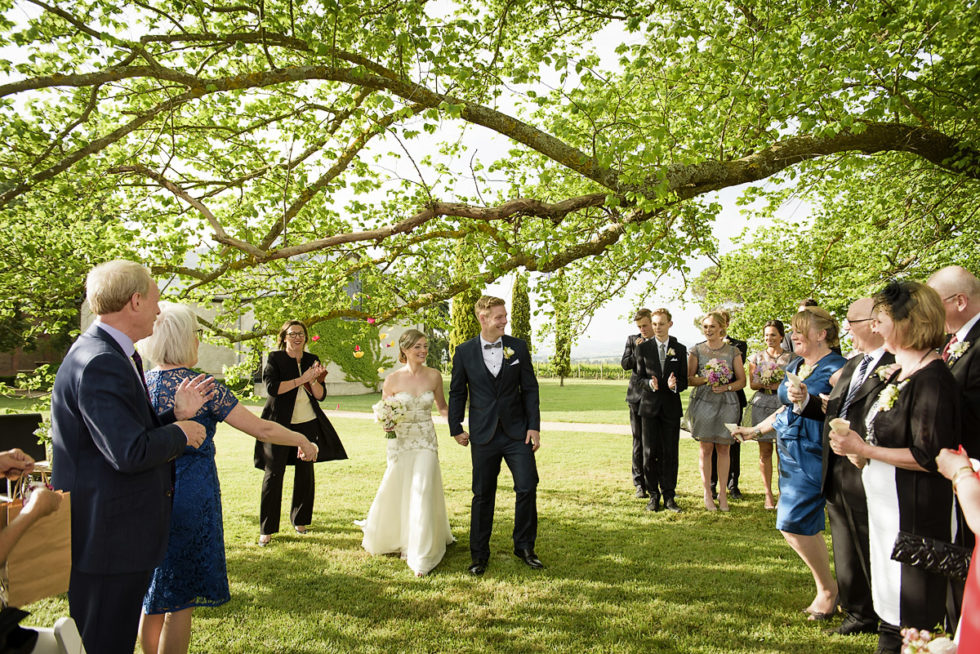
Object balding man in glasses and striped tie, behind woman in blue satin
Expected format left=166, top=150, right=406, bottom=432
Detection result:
left=801, top=297, right=895, bottom=635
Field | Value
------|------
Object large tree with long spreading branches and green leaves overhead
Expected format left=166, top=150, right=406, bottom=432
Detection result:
left=0, top=0, right=980, bottom=340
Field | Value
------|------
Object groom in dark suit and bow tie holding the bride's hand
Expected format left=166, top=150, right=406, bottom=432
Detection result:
left=449, top=295, right=544, bottom=575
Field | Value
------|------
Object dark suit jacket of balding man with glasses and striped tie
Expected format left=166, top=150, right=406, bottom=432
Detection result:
left=804, top=352, right=895, bottom=494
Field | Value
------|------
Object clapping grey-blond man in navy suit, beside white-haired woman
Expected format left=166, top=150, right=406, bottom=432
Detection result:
left=51, top=261, right=213, bottom=654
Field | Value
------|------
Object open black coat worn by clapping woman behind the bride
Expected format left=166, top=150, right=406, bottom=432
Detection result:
left=252, top=350, right=347, bottom=470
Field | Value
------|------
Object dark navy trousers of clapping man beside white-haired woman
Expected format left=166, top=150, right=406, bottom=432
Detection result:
left=68, top=568, right=153, bottom=654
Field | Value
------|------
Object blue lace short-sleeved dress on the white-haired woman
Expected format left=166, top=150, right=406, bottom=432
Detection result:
left=143, top=368, right=238, bottom=614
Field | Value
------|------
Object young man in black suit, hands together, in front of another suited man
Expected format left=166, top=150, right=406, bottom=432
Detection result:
left=637, top=309, right=687, bottom=513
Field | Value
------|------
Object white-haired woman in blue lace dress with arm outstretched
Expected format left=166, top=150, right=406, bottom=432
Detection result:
left=138, top=302, right=316, bottom=654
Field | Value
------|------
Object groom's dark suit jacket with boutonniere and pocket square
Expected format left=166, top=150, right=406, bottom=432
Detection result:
left=449, top=336, right=541, bottom=445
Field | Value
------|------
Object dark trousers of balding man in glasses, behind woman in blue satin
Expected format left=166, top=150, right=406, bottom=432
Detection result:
left=827, top=457, right=878, bottom=626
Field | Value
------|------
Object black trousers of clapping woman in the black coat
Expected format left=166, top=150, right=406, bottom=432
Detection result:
left=259, top=420, right=319, bottom=535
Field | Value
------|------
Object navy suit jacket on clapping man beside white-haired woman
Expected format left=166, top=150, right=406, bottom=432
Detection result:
left=51, top=325, right=187, bottom=574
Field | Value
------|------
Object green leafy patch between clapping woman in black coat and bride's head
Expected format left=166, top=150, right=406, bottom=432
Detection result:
left=308, top=320, right=398, bottom=390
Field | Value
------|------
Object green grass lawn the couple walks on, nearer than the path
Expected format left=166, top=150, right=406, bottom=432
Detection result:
left=26, top=418, right=875, bottom=654
